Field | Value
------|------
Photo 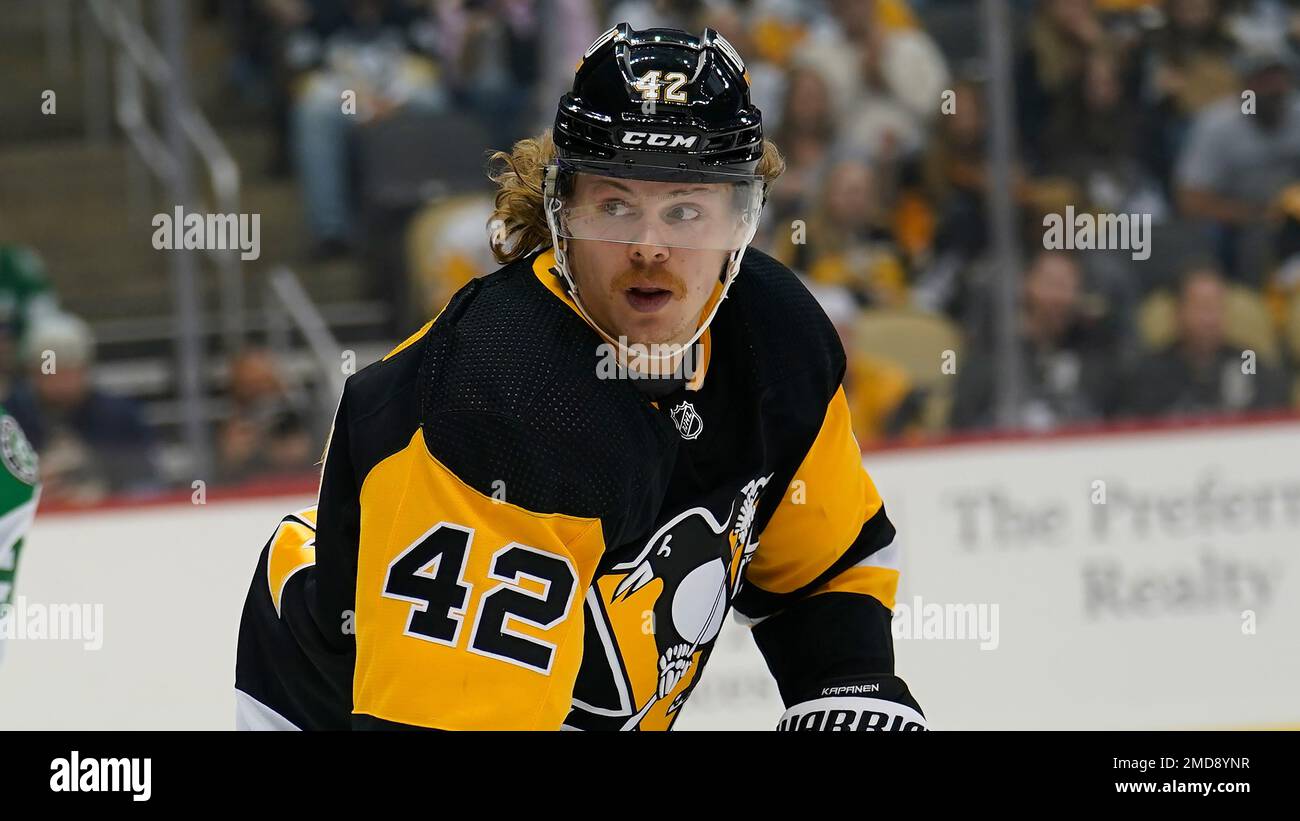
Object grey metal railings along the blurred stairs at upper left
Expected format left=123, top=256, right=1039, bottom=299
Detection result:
left=62, top=0, right=361, bottom=474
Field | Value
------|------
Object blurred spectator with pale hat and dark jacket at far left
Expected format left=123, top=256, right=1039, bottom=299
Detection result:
left=4, top=313, right=161, bottom=504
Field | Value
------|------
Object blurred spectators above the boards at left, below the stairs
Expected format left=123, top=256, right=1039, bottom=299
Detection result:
left=0, top=243, right=324, bottom=505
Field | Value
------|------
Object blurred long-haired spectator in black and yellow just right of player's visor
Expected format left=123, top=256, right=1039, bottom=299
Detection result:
left=775, top=157, right=907, bottom=305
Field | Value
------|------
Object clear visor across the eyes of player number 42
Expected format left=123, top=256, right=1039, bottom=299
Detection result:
left=546, top=162, right=763, bottom=251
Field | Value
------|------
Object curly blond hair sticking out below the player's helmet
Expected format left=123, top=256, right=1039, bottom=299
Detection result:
left=488, top=129, right=785, bottom=264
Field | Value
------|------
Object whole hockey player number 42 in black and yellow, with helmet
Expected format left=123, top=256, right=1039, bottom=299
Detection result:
left=235, top=25, right=926, bottom=730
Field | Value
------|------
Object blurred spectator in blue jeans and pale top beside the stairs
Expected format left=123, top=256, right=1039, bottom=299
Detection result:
left=286, top=0, right=447, bottom=257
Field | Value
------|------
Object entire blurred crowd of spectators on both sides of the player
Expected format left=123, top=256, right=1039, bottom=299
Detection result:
left=0, top=0, right=1300, bottom=496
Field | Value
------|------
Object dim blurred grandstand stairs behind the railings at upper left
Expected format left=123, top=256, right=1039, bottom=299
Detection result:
left=0, top=0, right=393, bottom=479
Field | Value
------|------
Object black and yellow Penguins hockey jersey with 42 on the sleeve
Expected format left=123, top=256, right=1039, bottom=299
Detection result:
left=235, top=249, right=898, bottom=729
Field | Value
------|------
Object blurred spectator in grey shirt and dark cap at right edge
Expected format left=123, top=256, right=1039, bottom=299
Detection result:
left=1177, top=42, right=1300, bottom=286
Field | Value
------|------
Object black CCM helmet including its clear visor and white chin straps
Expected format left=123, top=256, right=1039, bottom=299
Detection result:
left=542, top=23, right=767, bottom=353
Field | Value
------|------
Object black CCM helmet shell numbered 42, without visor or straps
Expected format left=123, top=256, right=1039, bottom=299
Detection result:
left=553, top=23, right=763, bottom=177
